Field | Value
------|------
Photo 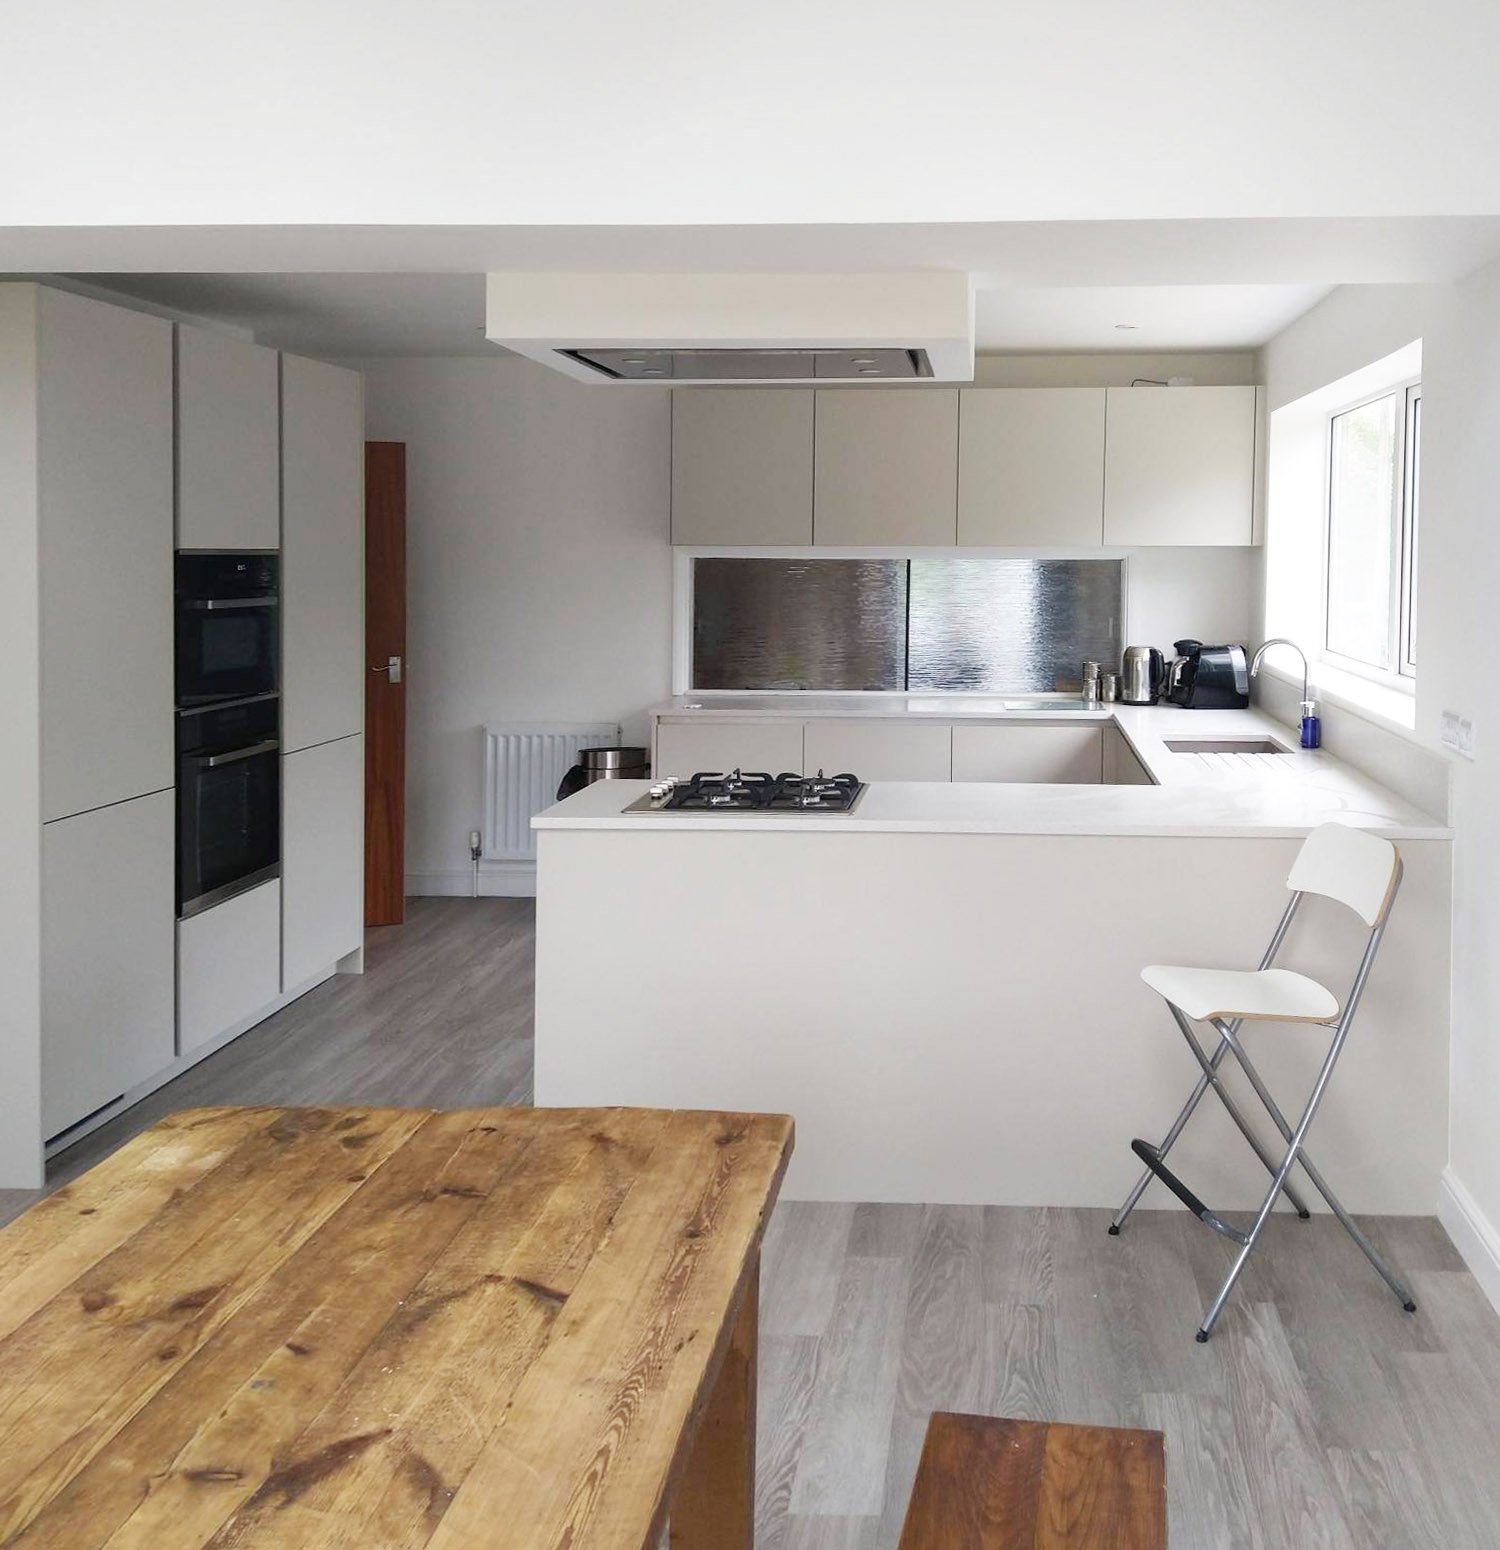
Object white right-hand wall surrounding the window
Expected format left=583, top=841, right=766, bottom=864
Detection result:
left=1264, top=265, right=1500, bottom=1304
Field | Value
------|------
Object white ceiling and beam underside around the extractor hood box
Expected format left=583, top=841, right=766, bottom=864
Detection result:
left=32, top=217, right=1500, bottom=357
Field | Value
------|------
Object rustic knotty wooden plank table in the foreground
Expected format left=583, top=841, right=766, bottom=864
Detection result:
left=0, top=1108, right=792, bottom=1550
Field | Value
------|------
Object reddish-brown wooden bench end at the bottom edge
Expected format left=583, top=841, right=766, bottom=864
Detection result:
left=900, top=1412, right=1167, bottom=1550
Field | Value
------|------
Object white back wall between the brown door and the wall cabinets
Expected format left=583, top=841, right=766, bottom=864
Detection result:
left=356, top=357, right=671, bottom=891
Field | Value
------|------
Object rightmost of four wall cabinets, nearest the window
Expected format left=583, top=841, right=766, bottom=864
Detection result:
left=1105, top=388, right=1255, bottom=546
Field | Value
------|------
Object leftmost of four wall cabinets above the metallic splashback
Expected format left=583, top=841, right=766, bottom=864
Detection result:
left=673, top=388, right=814, bottom=544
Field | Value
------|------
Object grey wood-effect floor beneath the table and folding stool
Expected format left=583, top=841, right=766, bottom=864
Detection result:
left=0, top=899, right=1500, bottom=1550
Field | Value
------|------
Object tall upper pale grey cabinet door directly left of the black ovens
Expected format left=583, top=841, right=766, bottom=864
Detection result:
left=37, top=288, right=174, bottom=818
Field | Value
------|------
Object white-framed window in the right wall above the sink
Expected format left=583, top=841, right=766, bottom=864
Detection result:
left=1323, top=383, right=1423, bottom=684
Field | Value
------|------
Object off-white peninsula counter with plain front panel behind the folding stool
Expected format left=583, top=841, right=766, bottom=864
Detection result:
left=535, top=707, right=1452, bottom=1214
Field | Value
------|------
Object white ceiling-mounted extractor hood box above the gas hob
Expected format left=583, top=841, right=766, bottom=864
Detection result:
left=485, top=271, right=975, bottom=386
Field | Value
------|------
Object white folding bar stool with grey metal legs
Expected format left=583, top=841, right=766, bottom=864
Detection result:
left=1110, top=823, right=1416, bottom=1341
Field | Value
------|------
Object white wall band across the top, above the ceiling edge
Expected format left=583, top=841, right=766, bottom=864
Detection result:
left=0, top=0, right=1500, bottom=225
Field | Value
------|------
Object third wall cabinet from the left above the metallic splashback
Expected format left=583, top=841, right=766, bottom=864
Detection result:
left=958, top=388, right=1105, bottom=547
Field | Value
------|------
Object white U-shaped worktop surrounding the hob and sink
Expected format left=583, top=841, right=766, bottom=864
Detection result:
left=532, top=694, right=1452, bottom=840
